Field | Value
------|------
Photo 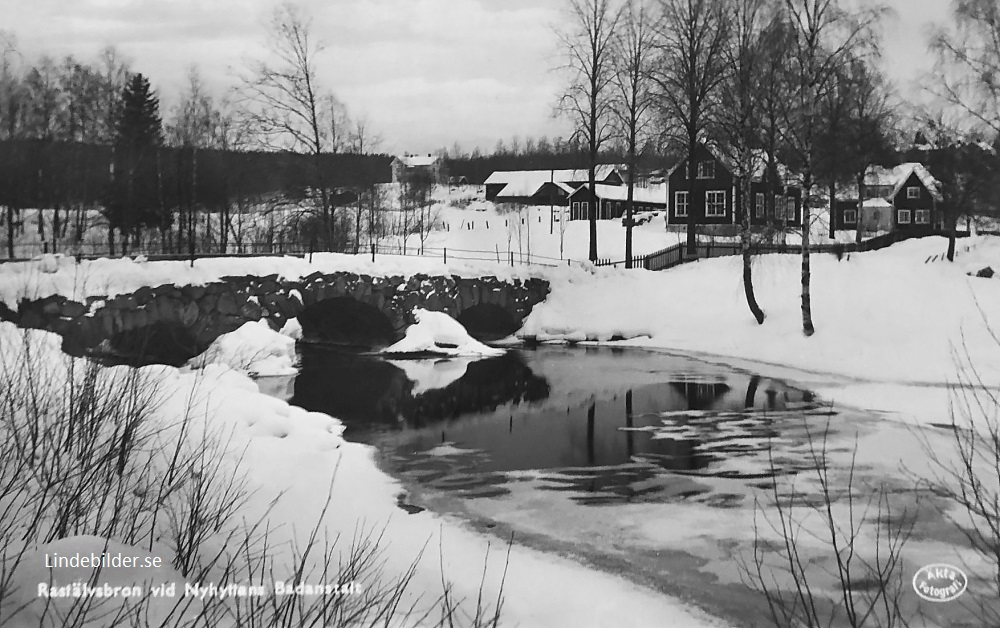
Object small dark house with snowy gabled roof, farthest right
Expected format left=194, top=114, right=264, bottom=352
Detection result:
left=836, top=162, right=944, bottom=233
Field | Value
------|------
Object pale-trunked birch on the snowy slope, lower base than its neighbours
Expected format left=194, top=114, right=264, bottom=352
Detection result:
left=784, top=0, right=885, bottom=336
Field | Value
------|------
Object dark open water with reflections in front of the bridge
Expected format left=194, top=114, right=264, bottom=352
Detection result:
left=292, top=347, right=828, bottom=503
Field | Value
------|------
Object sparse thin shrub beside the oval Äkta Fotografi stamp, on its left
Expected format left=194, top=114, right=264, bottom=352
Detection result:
left=740, top=422, right=915, bottom=628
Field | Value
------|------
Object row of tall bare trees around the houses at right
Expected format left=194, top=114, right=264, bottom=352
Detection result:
left=556, top=0, right=1000, bottom=336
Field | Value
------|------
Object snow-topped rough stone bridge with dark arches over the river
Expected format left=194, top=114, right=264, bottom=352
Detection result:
left=7, top=272, right=549, bottom=364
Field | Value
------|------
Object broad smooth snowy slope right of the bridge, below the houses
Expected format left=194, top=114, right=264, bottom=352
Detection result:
left=519, top=237, right=1000, bottom=384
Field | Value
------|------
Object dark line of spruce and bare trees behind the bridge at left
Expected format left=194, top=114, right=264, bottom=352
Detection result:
left=0, top=4, right=391, bottom=257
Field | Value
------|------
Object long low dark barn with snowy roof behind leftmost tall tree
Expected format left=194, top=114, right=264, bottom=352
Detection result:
left=486, top=164, right=622, bottom=206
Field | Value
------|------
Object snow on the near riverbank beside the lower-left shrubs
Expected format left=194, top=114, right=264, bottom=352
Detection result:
left=0, top=323, right=718, bottom=628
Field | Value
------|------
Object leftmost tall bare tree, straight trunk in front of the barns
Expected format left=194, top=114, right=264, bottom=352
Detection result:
left=557, top=0, right=621, bottom=262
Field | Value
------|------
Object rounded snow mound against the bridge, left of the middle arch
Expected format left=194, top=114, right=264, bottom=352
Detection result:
left=188, top=321, right=296, bottom=375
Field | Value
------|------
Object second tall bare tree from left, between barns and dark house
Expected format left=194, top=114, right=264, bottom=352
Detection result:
left=612, top=0, right=656, bottom=268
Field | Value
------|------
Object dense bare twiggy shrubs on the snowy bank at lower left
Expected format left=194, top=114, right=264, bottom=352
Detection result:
left=0, top=328, right=506, bottom=628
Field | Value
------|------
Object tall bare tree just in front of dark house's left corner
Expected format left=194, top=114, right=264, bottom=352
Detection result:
left=653, top=0, right=729, bottom=255
